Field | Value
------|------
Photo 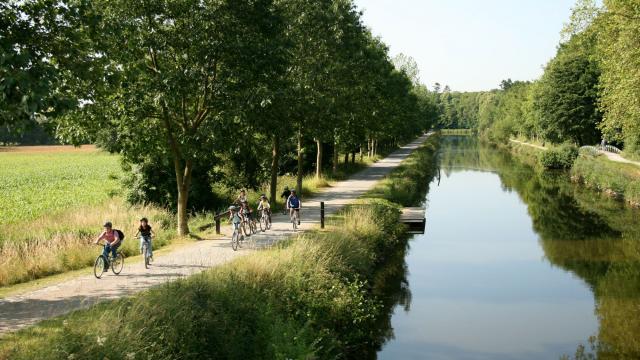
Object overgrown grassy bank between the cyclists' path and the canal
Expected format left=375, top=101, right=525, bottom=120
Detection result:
left=0, top=138, right=437, bottom=359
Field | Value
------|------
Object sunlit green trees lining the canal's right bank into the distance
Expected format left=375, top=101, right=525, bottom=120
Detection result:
left=440, top=0, right=640, bottom=155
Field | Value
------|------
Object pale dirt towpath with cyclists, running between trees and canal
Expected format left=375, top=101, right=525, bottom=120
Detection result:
left=0, top=135, right=427, bottom=335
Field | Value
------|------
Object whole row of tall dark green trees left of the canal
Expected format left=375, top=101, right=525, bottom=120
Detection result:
left=0, top=0, right=436, bottom=235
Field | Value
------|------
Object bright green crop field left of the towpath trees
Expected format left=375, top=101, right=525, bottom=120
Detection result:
left=0, top=150, right=120, bottom=228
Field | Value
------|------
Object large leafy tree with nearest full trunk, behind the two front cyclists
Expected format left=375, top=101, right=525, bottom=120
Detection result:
left=62, top=0, right=282, bottom=235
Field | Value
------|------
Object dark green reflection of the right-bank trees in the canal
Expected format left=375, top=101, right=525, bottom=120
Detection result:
left=440, top=137, right=640, bottom=359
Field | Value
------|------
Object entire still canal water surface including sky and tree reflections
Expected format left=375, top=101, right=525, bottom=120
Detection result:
left=378, top=137, right=640, bottom=359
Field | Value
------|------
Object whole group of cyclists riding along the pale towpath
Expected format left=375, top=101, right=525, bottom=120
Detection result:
left=95, top=186, right=302, bottom=271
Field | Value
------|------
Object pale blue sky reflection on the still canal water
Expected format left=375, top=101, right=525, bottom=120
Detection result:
left=380, top=171, right=598, bottom=359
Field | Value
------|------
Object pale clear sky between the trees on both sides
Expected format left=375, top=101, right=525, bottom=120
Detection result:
left=355, top=0, right=575, bottom=91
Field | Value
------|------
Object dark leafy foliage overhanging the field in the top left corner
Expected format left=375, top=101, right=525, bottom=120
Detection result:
left=0, top=0, right=89, bottom=128
